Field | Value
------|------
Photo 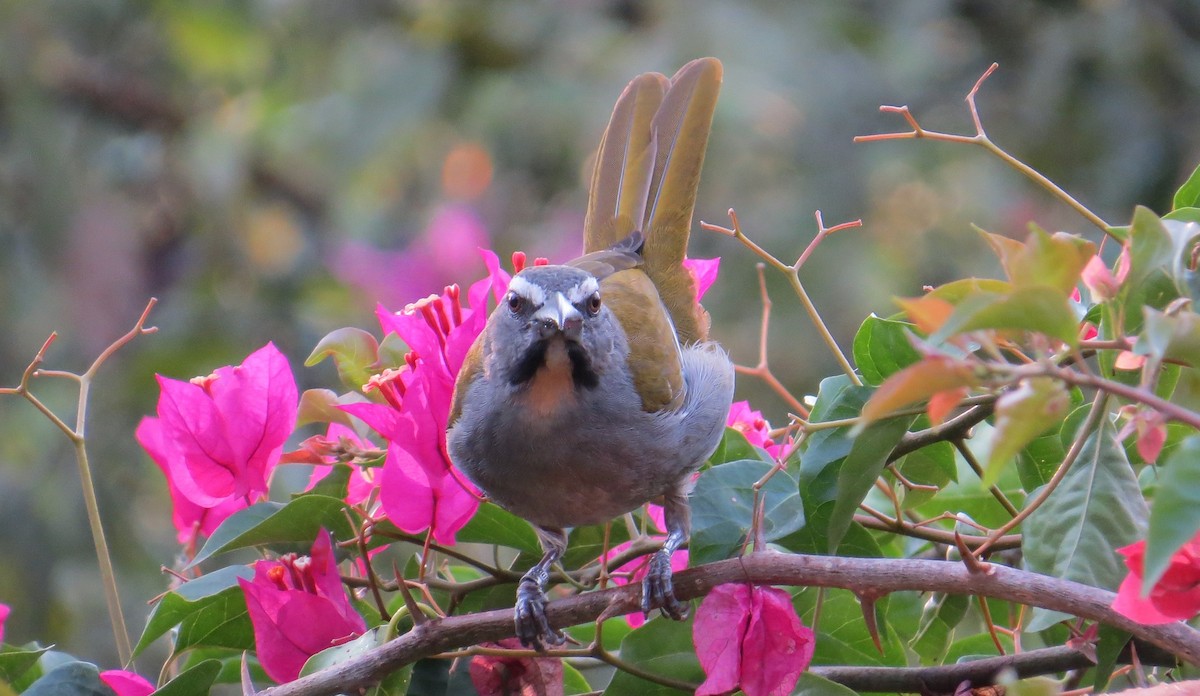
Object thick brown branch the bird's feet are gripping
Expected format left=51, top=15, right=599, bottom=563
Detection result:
left=259, top=552, right=1200, bottom=696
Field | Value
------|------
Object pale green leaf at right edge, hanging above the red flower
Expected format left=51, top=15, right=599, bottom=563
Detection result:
left=1142, top=434, right=1200, bottom=594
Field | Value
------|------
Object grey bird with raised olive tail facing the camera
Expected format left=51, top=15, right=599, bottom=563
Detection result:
left=446, top=58, right=734, bottom=652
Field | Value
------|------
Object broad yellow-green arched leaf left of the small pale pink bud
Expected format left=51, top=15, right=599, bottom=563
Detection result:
left=930, top=286, right=1079, bottom=346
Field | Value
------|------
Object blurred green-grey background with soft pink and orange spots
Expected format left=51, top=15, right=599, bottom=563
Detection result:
left=0, top=0, right=1200, bottom=676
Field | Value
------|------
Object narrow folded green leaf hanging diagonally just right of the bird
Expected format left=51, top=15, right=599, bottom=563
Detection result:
left=829, top=415, right=917, bottom=551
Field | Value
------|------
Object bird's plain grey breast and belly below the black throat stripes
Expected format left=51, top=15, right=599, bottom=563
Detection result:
left=449, top=369, right=694, bottom=527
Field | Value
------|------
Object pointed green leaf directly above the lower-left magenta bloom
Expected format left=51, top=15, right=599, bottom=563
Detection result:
left=187, top=496, right=354, bottom=568
